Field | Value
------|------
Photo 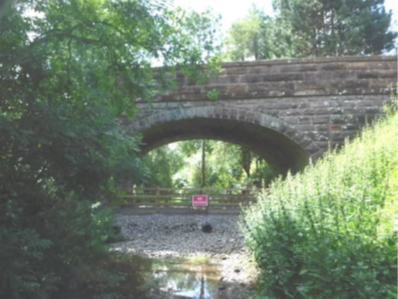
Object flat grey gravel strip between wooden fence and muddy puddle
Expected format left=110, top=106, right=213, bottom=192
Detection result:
left=114, top=214, right=246, bottom=257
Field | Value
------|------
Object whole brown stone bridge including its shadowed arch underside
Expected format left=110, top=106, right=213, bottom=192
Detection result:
left=125, top=56, right=398, bottom=173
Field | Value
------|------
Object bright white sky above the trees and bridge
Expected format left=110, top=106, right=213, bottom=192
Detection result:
left=174, top=0, right=398, bottom=33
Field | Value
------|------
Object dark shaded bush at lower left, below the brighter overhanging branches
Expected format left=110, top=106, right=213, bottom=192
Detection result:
left=0, top=101, right=145, bottom=298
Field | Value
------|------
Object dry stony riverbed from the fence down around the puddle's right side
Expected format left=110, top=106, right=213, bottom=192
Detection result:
left=113, top=214, right=256, bottom=299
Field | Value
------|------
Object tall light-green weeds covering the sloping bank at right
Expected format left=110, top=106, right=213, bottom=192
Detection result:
left=242, top=104, right=398, bottom=298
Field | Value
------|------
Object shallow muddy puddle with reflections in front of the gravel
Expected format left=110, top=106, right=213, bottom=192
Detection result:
left=139, top=258, right=220, bottom=299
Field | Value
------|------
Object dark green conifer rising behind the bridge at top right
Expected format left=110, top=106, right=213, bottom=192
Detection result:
left=273, top=0, right=397, bottom=57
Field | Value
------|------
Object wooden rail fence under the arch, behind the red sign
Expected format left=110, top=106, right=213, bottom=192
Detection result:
left=115, top=188, right=258, bottom=208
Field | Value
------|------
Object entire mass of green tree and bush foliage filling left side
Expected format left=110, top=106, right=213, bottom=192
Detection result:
left=0, top=0, right=219, bottom=298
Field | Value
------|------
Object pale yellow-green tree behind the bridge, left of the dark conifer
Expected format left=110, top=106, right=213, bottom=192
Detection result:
left=225, top=6, right=271, bottom=61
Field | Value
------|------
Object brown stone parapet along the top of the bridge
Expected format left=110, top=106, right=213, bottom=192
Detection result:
left=155, top=56, right=398, bottom=101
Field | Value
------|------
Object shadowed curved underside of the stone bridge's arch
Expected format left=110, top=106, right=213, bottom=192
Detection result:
left=135, top=117, right=310, bottom=174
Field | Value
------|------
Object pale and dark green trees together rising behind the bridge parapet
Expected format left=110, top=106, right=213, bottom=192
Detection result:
left=226, top=0, right=397, bottom=61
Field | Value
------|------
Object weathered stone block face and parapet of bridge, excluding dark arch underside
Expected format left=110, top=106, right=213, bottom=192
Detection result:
left=125, top=56, right=398, bottom=166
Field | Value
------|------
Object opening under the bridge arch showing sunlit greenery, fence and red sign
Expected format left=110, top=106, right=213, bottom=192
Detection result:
left=114, top=139, right=277, bottom=215
